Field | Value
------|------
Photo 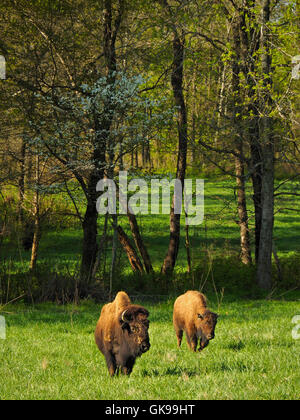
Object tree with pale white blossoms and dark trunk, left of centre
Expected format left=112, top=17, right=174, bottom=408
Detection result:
left=31, top=72, right=172, bottom=285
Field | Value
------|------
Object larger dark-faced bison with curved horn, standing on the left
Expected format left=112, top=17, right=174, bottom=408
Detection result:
left=95, top=292, right=150, bottom=376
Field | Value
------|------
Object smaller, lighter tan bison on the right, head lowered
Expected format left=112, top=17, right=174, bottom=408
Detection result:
left=173, top=290, right=218, bottom=351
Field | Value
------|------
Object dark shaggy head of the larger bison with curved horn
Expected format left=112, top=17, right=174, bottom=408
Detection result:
left=119, top=305, right=150, bottom=356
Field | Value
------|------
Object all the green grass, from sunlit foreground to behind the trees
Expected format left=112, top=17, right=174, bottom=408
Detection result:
left=0, top=180, right=300, bottom=400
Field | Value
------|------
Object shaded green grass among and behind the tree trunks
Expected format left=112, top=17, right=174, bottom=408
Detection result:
left=0, top=179, right=300, bottom=300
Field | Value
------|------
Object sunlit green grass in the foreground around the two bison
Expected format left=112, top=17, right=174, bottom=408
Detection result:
left=0, top=293, right=300, bottom=400
